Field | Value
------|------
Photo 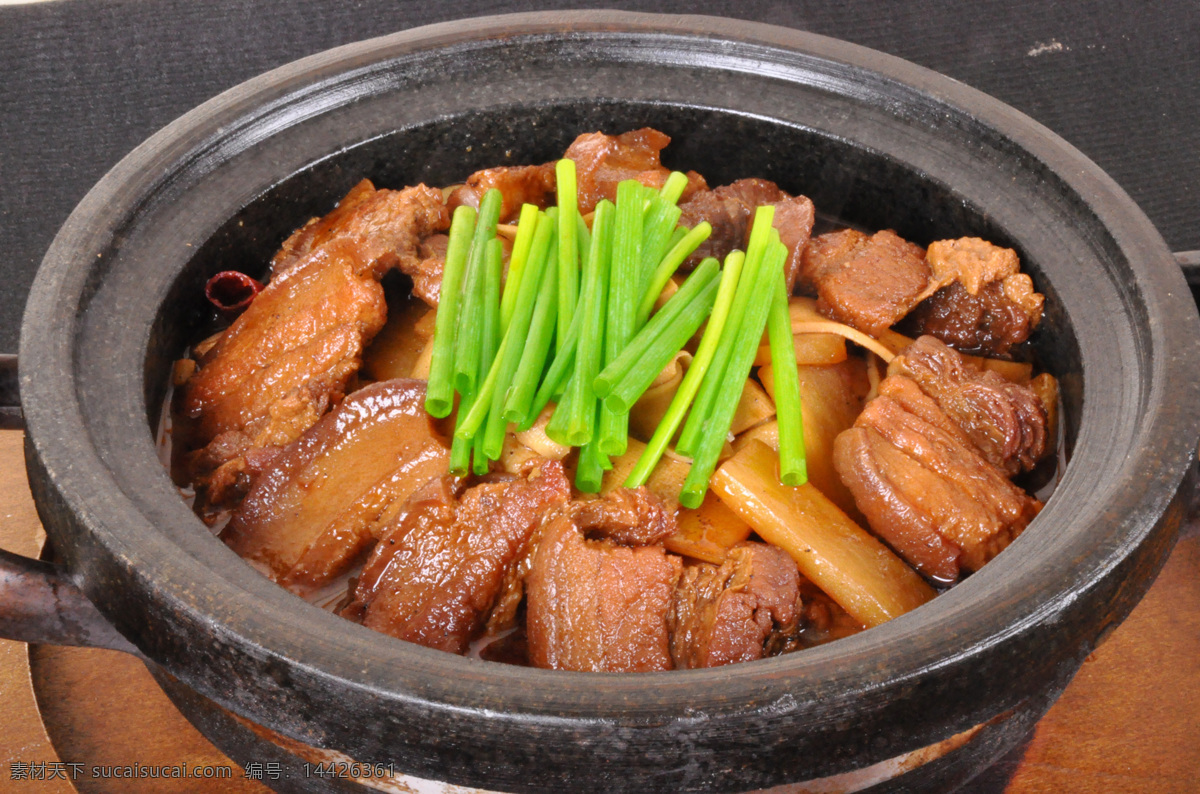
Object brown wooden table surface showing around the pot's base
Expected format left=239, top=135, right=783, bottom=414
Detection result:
left=0, top=431, right=1200, bottom=794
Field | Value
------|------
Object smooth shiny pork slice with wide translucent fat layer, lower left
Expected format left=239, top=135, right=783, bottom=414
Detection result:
left=222, top=379, right=449, bottom=595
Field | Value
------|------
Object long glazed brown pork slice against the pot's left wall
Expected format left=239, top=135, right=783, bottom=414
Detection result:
left=176, top=241, right=388, bottom=505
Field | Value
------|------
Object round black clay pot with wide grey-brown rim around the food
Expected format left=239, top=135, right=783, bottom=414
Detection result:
left=9, top=12, right=1200, bottom=792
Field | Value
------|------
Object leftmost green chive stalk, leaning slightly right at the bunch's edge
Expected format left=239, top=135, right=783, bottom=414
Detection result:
left=425, top=206, right=475, bottom=419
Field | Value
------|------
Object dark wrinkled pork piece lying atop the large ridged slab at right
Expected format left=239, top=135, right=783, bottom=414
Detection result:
left=888, top=336, right=1048, bottom=477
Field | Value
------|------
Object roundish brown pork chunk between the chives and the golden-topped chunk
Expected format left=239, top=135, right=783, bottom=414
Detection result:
left=799, top=229, right=930, bottom=336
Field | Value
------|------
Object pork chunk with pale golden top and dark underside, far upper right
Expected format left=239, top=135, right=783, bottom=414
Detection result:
left=905, top=237, right=1045, bottom=356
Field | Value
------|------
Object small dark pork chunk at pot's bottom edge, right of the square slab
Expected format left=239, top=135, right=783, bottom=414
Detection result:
left=671, top=542, right=803, bottom=669
